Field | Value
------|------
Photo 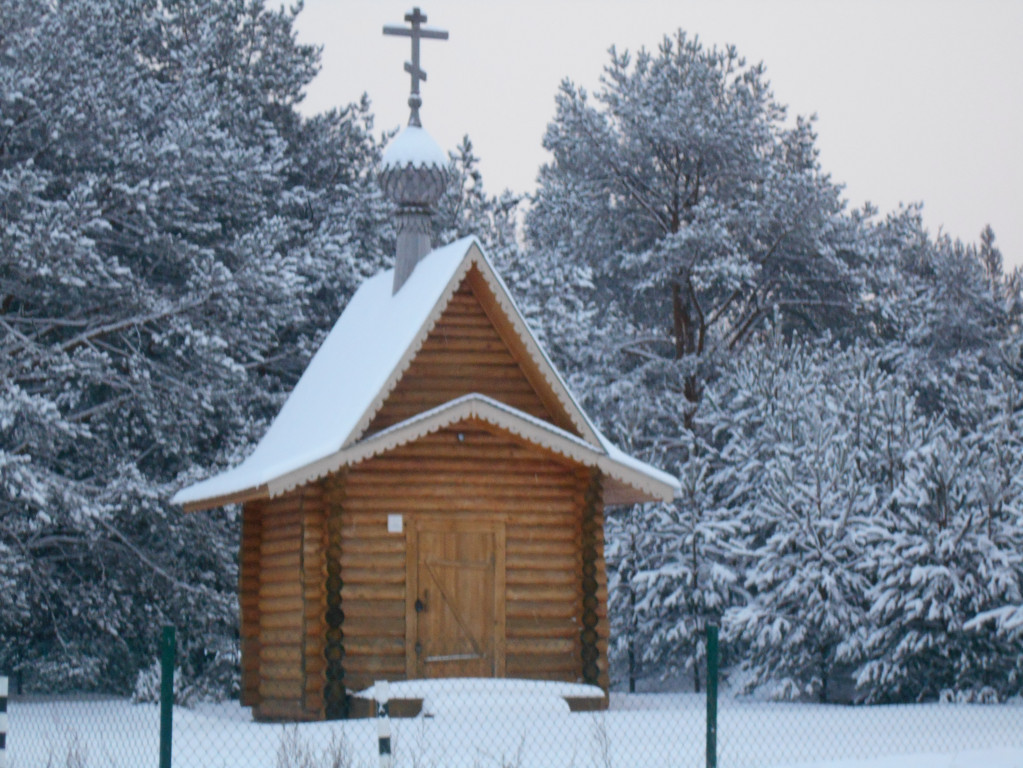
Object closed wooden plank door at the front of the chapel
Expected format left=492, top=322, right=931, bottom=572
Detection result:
left=406, top=525, right=504, bottom=678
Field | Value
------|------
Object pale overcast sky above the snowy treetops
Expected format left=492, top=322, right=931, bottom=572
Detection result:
left=290, top=0, right=1023, bottom=265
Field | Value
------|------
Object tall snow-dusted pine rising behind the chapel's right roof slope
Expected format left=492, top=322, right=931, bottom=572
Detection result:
left=526, top=32, right=862, bottom=683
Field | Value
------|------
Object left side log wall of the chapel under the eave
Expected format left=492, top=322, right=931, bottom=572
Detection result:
left=241, top=484, right=326, bottom=720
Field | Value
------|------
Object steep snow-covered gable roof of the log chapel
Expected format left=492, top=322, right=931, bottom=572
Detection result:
left=171, top=237, right=678, bottom=509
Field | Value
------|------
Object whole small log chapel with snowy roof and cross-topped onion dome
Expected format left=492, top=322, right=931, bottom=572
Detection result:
left=174, top=9, right=678, bottom=721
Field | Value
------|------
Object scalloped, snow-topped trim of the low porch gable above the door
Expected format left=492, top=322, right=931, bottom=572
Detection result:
left=267, top=393, right=675, bottom=501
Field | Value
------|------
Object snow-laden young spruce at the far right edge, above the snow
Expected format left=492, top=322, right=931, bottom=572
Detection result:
left=858, top=373, right=1023, bottom=702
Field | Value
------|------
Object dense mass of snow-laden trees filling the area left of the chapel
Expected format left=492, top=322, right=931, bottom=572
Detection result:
left=0, top=0, right=390, bottom=690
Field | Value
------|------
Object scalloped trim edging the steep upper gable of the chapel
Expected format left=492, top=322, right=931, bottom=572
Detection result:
left=342, top=239, right=606, bottom=443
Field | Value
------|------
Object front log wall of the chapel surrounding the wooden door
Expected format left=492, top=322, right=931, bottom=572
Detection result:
left=328, top=422, right=607, bottom=690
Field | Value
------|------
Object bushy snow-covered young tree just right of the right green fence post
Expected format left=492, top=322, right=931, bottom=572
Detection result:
left=701, top=340, right=915, bottom=702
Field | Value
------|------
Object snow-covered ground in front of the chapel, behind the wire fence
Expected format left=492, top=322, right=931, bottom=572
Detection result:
left=7, top=681, right=1023, bottom=768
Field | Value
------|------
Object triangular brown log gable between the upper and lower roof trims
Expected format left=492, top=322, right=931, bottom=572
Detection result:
left=364, top=266, right=580, bottom=436
